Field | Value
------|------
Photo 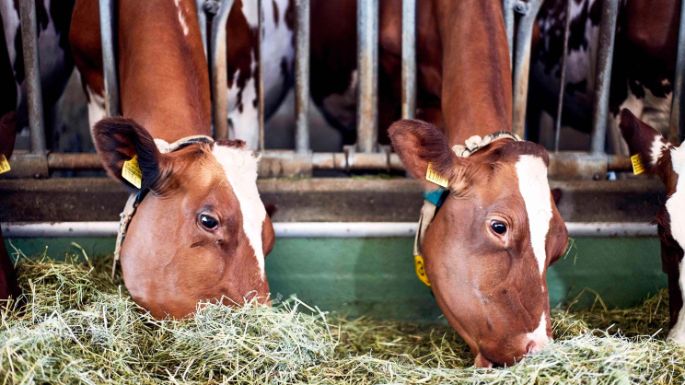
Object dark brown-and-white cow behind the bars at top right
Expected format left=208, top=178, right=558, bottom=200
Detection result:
left=528, top=0, right=680, bottom=153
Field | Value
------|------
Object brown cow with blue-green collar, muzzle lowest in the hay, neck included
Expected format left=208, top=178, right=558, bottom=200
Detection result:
left=311, top=0, right=567, bottom=366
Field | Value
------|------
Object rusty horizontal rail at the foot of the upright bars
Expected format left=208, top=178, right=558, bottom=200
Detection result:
left=4, top=151, right=631, bottom=171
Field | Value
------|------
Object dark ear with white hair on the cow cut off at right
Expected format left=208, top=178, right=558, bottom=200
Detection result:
left=619, top=108, right=670, bottom=171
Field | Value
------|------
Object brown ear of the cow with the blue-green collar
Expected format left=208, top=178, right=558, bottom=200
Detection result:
left=388, top=119, right=456, bottom=180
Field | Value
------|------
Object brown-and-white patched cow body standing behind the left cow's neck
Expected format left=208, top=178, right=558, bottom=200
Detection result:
left=77, top=0, right=295, bottom=150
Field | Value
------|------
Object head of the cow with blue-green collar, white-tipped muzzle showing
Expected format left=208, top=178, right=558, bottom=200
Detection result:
left=390, top=120, right=568, bottom=366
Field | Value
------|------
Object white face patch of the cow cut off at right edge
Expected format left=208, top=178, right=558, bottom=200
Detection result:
left=666, top=146, right=685, bottom=345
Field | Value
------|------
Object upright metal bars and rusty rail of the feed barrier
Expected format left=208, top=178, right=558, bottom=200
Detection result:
left=5, top=0, right=685, bottom=235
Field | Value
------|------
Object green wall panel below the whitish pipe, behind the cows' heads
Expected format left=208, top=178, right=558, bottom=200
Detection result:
left=6, top=238, right=666, bottom=321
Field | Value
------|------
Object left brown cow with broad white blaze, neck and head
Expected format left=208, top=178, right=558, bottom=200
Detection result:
left=70, top=0, right=274, bottom=317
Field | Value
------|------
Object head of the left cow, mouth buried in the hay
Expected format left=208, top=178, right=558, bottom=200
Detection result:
left=94, top=118, right=274, bottom=317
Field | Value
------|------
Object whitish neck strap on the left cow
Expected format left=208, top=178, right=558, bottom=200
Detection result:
left=112, top=135, right=214, bottom=279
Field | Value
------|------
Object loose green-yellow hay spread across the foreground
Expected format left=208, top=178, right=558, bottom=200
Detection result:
left=0, top=248, right=685, bottom=384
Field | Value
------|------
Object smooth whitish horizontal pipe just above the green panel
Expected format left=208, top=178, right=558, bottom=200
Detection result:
left=0, top=221, right=657, bottom=238
